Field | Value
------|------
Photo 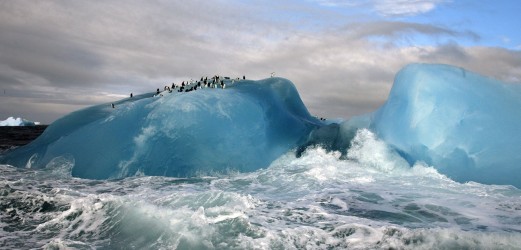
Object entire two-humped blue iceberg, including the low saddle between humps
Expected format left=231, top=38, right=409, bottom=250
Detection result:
left=0, top=64, right=521, bottom=187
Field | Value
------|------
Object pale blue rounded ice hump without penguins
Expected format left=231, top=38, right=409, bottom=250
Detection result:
left=370, top=64, right=521, bottom=187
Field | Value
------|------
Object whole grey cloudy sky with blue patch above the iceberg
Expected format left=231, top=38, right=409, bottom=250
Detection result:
left=0, top=0, right=521, bottom=124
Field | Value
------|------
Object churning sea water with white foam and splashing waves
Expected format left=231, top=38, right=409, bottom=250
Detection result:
left=0, top=129, right=521, bottom=249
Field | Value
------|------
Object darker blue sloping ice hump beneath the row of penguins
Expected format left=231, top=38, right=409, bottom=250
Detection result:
left=3, top=78, right=321, bottom=179
